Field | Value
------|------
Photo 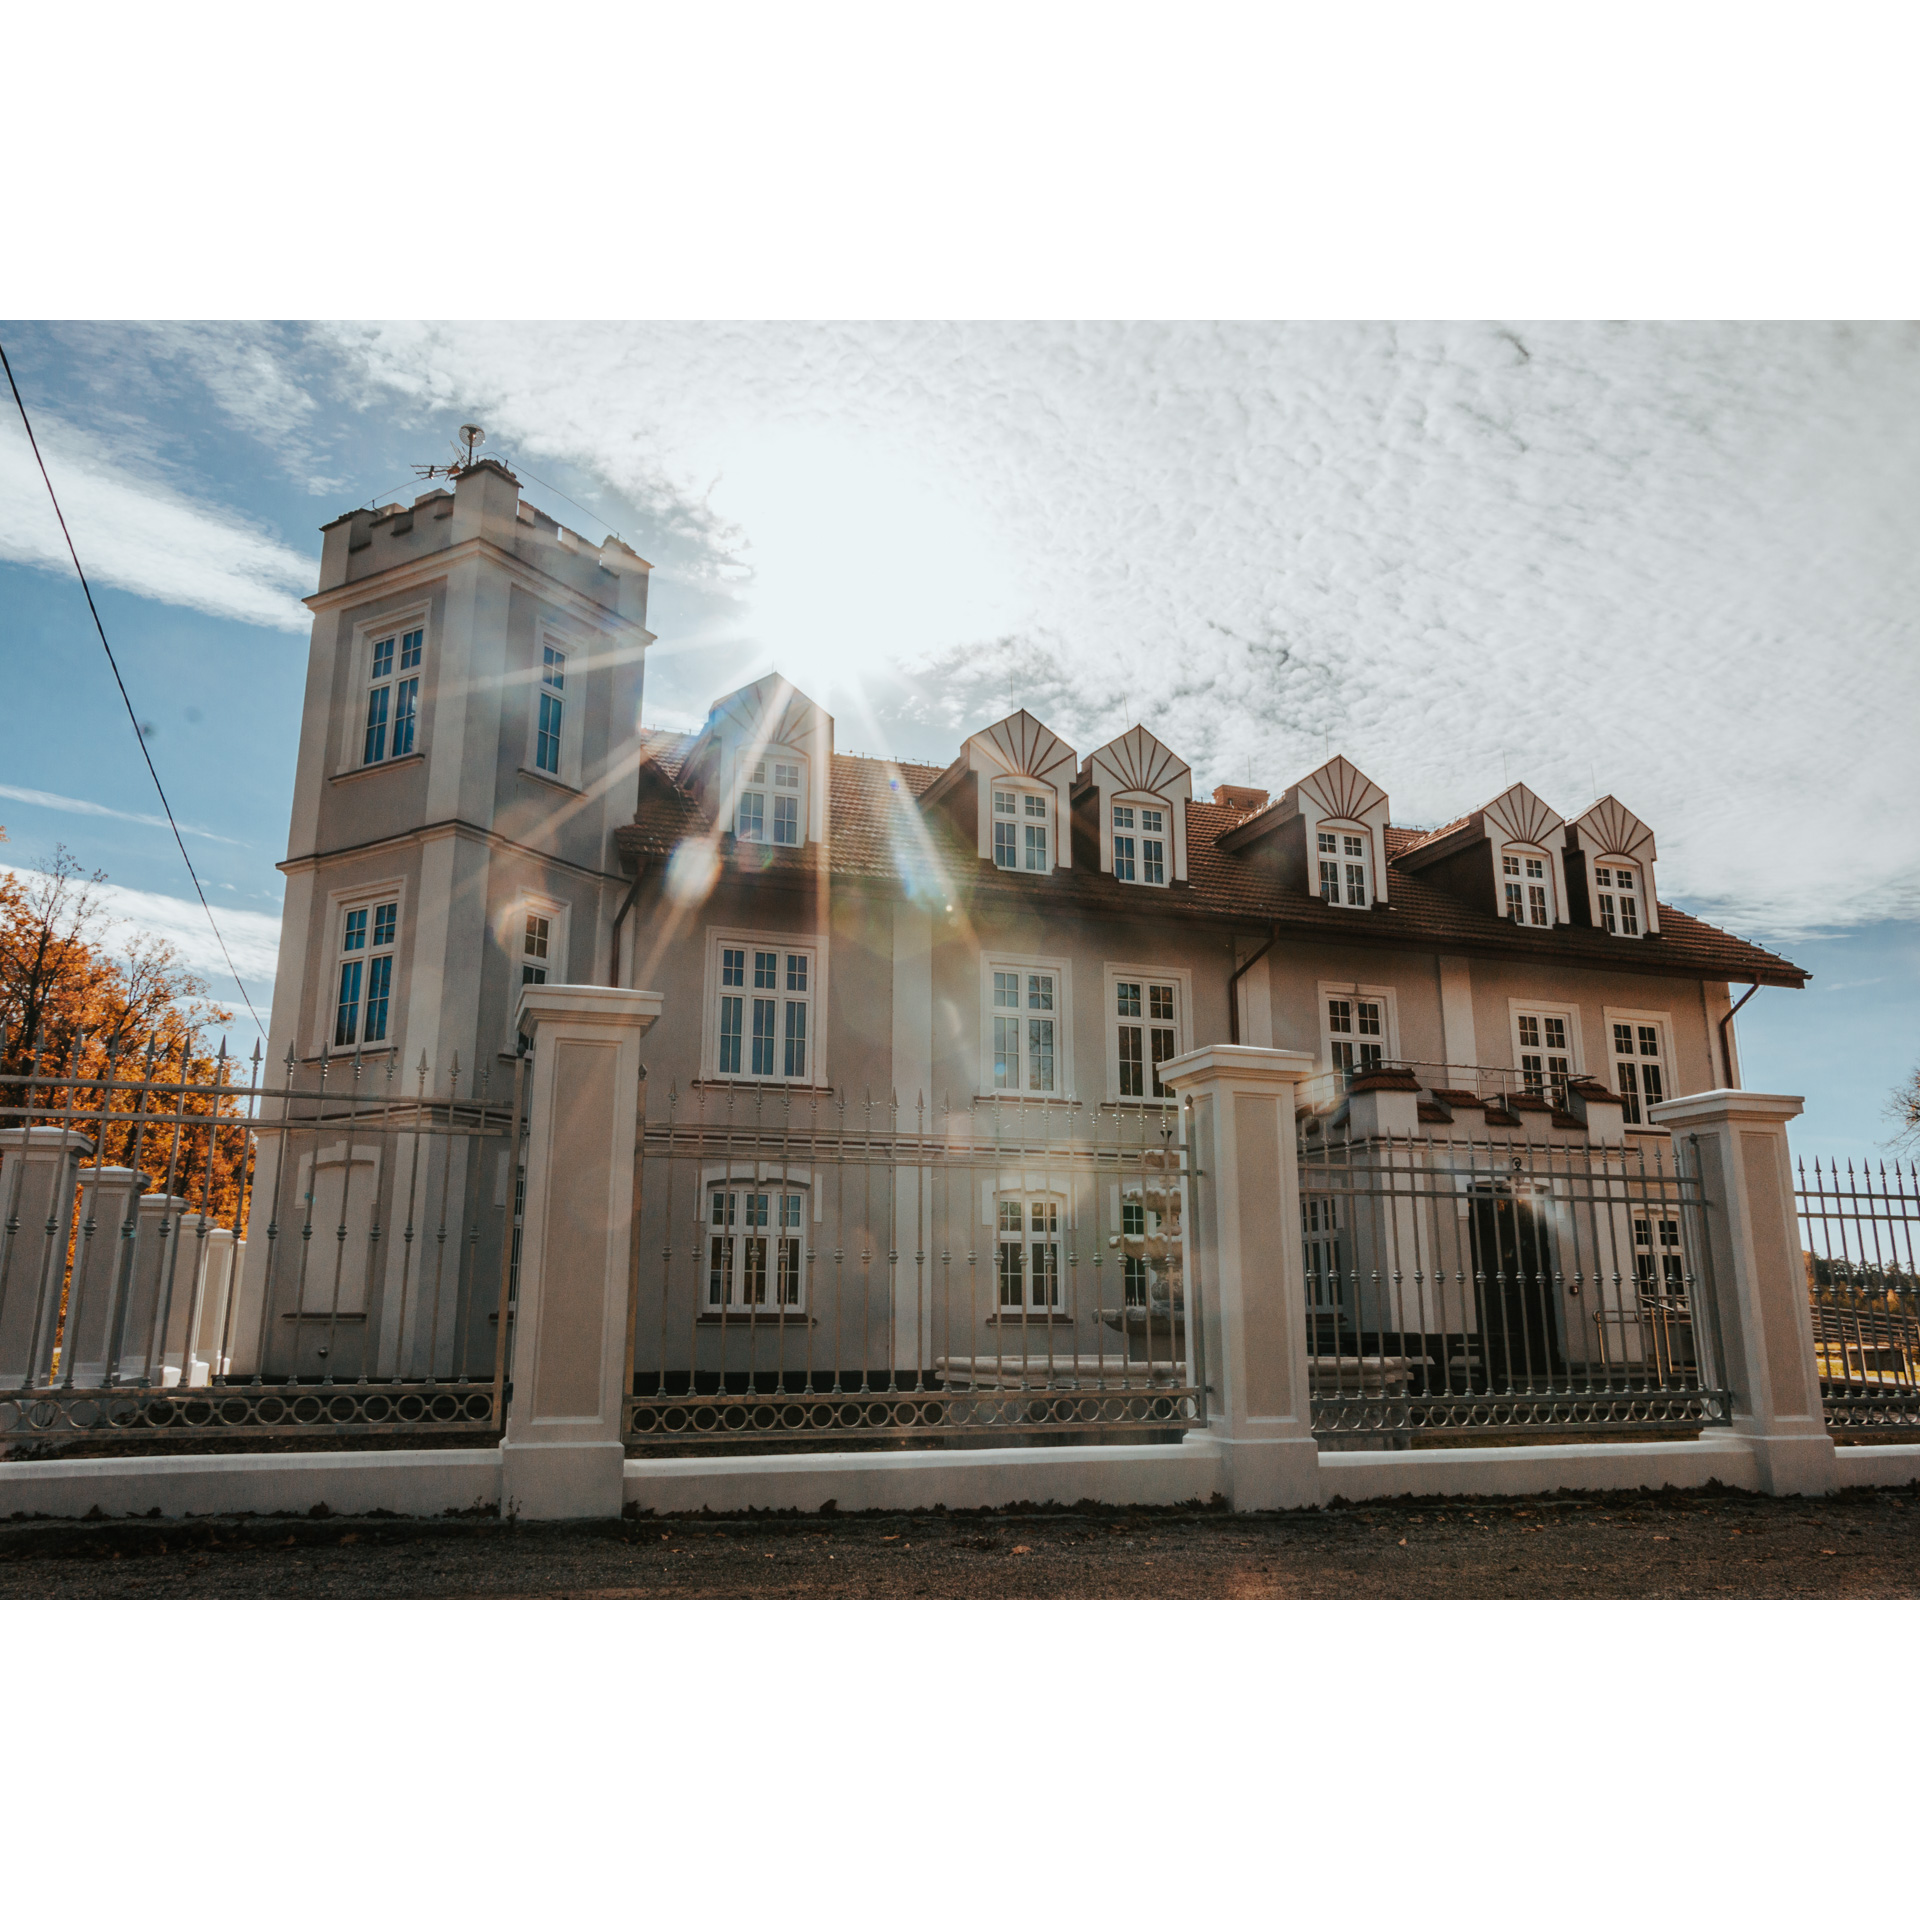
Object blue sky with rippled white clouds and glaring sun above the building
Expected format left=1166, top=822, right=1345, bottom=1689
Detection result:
left=0, top=324, right=1920, bottom=1152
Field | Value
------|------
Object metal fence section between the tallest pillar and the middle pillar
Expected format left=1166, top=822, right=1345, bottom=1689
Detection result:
left=626, top=1085, right=1204, bottom=1448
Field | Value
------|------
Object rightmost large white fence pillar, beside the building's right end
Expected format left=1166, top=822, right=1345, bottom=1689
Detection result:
left=1647, top=1087, right=1837, bottom=1494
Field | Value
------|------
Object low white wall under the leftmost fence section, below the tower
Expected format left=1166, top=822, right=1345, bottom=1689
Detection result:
left=0, top=1448, right=499, bottom=1519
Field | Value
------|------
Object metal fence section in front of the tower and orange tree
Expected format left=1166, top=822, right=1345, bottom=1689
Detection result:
left=0, top=1041, right=524, bottom=1442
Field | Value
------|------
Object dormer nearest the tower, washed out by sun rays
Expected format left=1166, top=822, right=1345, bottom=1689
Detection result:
left=687, top=674, right=833, bottom=845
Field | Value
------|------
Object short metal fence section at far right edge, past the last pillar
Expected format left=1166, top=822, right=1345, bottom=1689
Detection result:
left=1793, top=1160, right=1920, bottom=1428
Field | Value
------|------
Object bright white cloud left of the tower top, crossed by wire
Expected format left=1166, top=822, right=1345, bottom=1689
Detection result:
left=0, top=411, right=315, bottom=634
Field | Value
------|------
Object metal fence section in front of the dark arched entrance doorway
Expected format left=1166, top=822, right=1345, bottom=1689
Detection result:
left=1300, top=1137, right=1730, bottom=1442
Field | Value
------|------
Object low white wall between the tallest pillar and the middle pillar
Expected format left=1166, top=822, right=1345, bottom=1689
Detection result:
left=626, top=1434, right=1221, bottom=1513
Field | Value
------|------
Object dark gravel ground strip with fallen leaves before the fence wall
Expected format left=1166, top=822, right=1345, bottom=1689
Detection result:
left=0, top=1490, right=1920, bottom=1599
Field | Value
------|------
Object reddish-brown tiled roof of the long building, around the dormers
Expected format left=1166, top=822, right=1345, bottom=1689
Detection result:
left=614, top=733, right=1809, bottom=987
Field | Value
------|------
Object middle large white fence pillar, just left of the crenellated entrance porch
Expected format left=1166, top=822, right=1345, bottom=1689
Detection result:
left=1160, top=1046, right=1321, bottom=1513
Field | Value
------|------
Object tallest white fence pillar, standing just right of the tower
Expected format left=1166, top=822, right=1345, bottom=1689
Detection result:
left=501, top=987, right=660, bottom=1521
